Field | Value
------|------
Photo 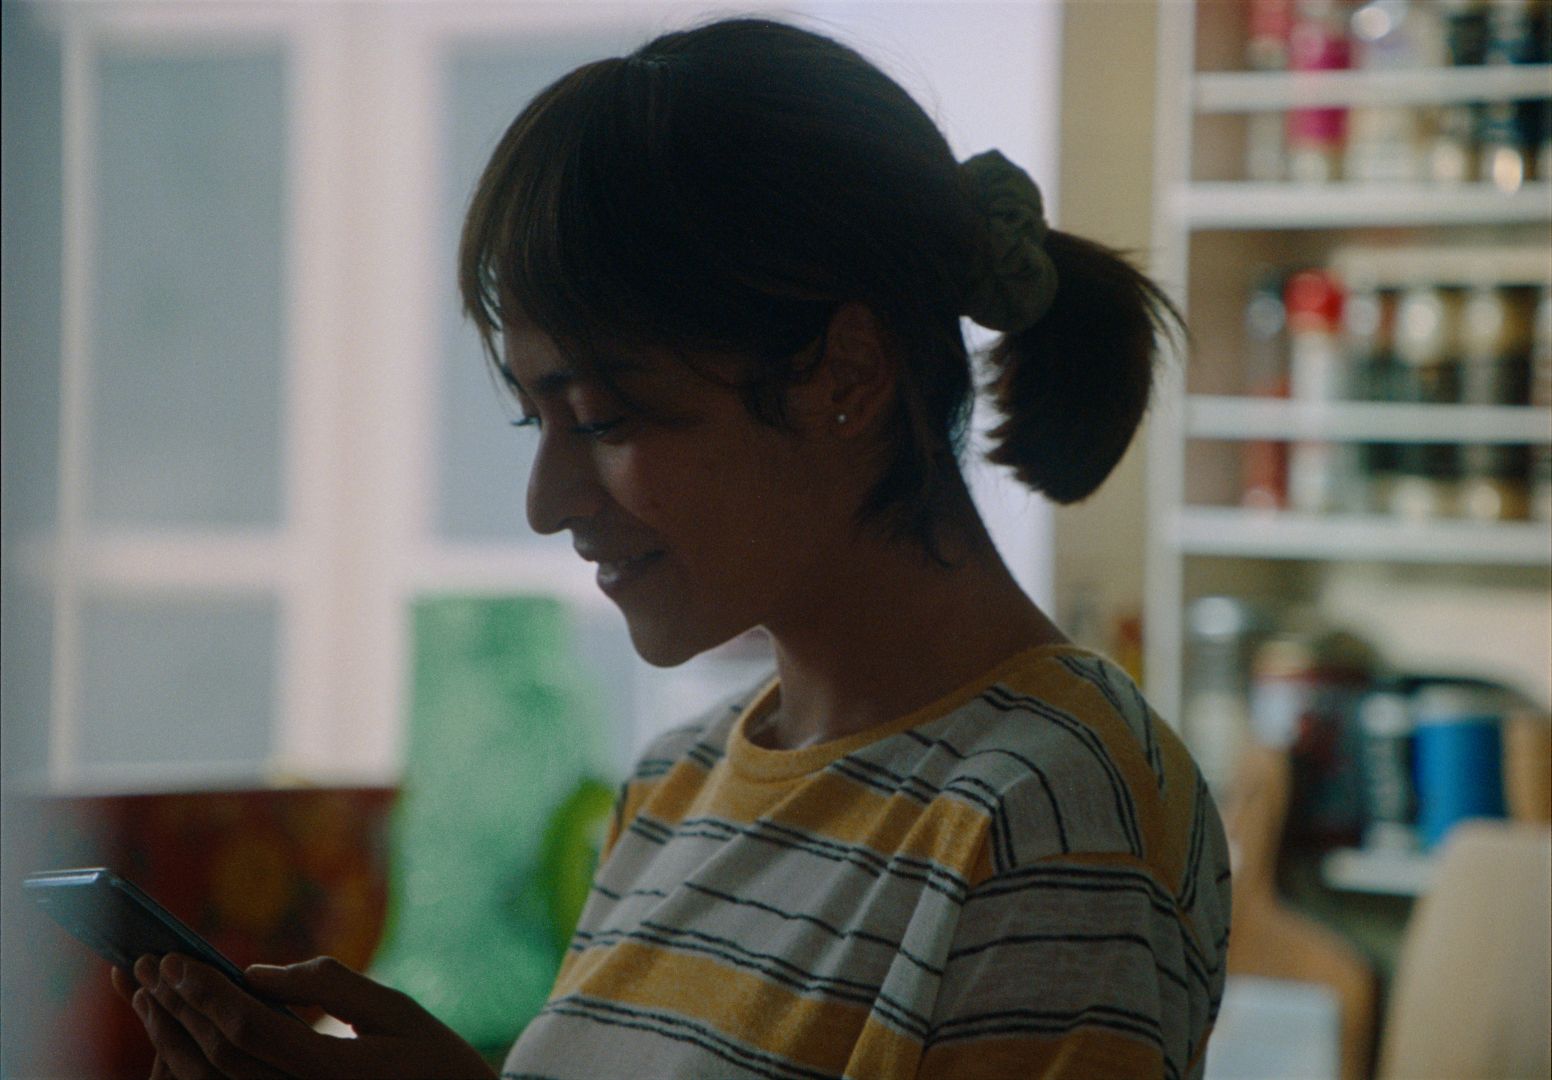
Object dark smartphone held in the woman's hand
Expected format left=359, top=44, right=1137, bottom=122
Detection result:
left=22, top=866, right=301, bottom=1021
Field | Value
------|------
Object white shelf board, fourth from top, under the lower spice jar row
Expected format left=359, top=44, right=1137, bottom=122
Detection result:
left=1170, top=506, right=1552, bottom=566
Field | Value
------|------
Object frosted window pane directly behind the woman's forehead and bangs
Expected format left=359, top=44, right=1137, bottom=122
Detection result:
left=436, top=33, right=644, bottom=546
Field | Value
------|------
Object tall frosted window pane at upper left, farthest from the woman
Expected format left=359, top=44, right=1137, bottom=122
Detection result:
left=88, top=47, right=286, bottom=526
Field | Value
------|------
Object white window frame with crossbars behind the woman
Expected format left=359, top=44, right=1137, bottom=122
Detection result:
left=23, top=0, right=1060, bottom=790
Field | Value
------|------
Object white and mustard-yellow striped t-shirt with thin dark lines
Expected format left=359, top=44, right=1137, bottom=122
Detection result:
left=503, top=646, right=1229, bottom=1080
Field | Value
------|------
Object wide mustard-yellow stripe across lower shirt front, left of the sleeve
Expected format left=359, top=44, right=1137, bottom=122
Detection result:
left=551, top=942, right=868, bottom=1072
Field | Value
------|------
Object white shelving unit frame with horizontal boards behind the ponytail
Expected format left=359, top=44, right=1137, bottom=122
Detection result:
left=1145, top=0, right=1552, bottom=892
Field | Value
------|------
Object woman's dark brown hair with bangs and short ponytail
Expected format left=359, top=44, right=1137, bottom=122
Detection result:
left=459, top=19, right=1178, bottom=557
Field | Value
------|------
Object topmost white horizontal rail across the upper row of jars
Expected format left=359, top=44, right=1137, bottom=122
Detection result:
left=1192, top=64, right=1552, bottom=113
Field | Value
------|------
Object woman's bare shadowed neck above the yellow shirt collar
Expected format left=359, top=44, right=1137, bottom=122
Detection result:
left=753, top=520, right=1066, bottom=749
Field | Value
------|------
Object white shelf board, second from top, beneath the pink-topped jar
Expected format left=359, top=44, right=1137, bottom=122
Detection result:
left=1170, top=180, right=1552, bottom=230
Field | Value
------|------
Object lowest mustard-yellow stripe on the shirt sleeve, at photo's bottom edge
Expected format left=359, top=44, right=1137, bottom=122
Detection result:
left=916, top=1027, right=1164, bottom=1080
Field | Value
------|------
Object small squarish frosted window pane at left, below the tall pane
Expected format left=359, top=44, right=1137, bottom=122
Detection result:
left=79, top=596, right=279, bottom=773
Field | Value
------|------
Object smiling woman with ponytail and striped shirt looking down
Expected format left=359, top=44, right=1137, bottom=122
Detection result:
left=126, top=20, right=1229, bottom=1080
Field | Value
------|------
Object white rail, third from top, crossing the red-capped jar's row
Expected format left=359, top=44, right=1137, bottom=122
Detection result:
left=1184, top=394, right=1552, bottom=444
